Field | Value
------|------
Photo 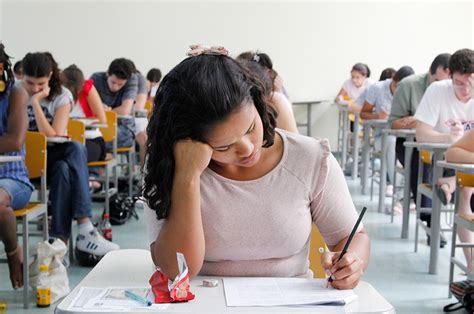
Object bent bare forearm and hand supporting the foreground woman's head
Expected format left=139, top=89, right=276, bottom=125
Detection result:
left=152, top=139, right=212, bottom=279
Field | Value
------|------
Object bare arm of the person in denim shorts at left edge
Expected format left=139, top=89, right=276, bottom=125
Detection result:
left=0, top=87, right=28, bottom=153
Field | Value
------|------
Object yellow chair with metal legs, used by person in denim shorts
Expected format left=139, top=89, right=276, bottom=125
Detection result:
left=11, top=132, right=48, bottom=309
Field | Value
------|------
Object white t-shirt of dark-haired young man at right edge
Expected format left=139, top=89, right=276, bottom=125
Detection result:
left=415, top=80, right=474, bottom=133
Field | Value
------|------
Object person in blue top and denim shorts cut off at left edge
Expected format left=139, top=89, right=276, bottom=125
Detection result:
left=0, top=43, right=33, bottom=289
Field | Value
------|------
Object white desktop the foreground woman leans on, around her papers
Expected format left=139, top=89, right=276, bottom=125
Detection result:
left=55, top=250, right=395, bottom=314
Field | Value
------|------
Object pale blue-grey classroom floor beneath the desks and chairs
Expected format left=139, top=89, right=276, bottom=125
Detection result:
left=0, top=178, right=462, bottom=314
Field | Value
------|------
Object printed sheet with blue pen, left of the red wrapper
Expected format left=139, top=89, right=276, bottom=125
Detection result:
left=68, top=287, right=169, bottom=313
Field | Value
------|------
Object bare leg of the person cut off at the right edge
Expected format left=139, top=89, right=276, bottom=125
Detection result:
left=458, top=188, right=474, bottom=272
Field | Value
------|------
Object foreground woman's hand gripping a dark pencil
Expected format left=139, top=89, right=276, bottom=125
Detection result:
left=321, top=251, right=364, bottom=289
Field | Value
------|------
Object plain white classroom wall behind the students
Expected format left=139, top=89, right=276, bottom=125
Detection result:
left=0, top=0, right=474, bottom=147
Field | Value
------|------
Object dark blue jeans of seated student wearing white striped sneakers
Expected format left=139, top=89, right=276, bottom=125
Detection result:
left=48, top=141, right=92, bottom=239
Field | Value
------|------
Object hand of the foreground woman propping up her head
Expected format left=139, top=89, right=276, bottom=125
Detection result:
left=174, top=139, right=213, bottom=176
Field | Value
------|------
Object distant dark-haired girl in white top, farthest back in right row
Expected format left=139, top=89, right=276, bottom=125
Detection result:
left=335, top=63, right=373, bottom=111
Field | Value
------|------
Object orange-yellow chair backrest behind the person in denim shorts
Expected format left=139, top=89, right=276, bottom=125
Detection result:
left=25, top=132, right=46, bottom=179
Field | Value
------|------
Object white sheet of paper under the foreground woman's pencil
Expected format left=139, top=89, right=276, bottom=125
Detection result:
left=223, top=277, right=357, bottom=306
